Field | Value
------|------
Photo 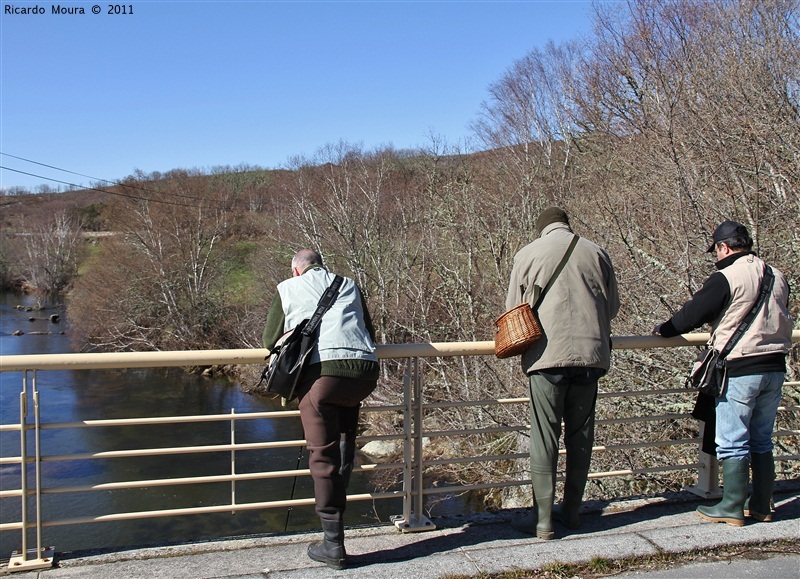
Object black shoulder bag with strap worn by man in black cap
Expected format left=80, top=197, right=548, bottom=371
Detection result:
left=685, top=265, right=775, bottom=398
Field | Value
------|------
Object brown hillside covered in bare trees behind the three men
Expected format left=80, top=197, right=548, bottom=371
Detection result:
left=0, top=0, right=800, bottom=500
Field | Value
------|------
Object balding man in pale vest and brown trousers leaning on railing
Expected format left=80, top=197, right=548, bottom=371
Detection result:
left=263, top=249, right=380, bottom=569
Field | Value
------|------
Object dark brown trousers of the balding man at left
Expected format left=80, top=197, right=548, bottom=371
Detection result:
left=300, top=376, right=378, bottom=521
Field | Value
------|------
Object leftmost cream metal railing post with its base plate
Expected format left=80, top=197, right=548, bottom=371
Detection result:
left=8, top=370, right=55, bottom=572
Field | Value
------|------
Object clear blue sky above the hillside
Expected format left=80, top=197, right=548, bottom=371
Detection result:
left=0, top=0, right=591, bottom=193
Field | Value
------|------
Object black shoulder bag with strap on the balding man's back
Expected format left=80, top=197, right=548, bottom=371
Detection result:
left=256, top=275, right=343, bottom=401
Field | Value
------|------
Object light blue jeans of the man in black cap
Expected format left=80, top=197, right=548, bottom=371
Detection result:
left=716, top=372, right=784, bottom=460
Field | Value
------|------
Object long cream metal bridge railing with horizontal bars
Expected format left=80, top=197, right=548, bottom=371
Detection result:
left=0, top=331, right=800, bottom=571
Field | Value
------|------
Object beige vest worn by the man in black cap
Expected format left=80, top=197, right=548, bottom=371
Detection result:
left=712, top=255, right=792, bottom=359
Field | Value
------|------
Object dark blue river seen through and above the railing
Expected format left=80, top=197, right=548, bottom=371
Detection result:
left=0, top=294, right=402, bottom=558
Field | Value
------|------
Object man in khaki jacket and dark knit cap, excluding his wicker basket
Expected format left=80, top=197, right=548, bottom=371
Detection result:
left=506, top=207, right=620, bottom=539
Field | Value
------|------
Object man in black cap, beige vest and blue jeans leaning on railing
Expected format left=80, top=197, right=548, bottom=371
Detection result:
left=653, top=221, right=792, bottom=527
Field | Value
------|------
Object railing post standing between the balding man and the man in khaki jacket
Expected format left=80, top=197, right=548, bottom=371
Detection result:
left=390, top=358, right=436, bottom=532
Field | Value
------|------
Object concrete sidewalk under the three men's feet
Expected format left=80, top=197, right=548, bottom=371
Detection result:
left=0, top=484, right=800, bottom=579
